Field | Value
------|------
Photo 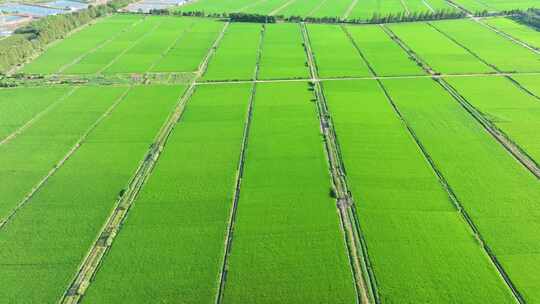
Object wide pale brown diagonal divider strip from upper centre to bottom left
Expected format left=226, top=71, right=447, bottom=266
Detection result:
left=58, top=22, right=229, bottom=304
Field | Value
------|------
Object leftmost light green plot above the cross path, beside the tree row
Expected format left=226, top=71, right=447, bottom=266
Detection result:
left=22, top=15, right=142, bottom=74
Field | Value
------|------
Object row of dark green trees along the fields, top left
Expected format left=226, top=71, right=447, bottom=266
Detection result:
left=0, top=0, right=131, bottom=72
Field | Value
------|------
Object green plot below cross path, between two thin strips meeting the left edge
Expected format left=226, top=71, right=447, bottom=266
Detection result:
left=0, top=87, right=126, bottom=221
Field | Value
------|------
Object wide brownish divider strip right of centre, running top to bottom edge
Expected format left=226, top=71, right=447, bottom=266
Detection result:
left=300, top=22, right=379, bottom=303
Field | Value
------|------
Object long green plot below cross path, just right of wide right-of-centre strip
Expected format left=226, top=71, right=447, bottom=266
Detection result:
left=323, top=80, right=512, bottom=303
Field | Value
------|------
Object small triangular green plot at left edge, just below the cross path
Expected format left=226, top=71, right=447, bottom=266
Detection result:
left=0, top=87, right=70, bottom=140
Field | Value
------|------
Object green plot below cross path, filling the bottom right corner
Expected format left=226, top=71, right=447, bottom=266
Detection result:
left=384, top=79, right=540, bottom=303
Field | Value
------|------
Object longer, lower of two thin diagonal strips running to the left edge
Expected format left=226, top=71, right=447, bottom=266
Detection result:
left=0, top=88, right=130, bottom=230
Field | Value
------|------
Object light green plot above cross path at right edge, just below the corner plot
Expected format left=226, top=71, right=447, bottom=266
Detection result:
left=432, top=19, right=540, bottom=72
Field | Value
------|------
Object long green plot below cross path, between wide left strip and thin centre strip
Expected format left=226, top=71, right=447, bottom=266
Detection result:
left=83, top=85, right=251, bottom=303
